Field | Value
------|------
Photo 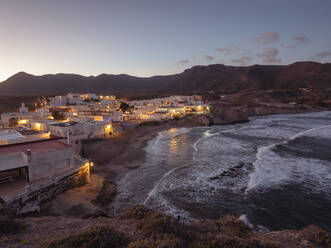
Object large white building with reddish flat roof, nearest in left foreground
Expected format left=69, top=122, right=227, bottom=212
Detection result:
left=0, top=139, right=90, bottom=202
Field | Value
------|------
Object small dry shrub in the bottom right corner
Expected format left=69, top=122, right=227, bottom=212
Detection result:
left=297, top=225, right=331, bottom=247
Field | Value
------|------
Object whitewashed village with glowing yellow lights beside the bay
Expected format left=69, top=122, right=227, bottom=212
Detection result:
left=0, top=93, right=210, bottom=214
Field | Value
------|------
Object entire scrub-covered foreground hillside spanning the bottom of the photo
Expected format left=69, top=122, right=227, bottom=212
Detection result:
left=0, top=206, right=331, bottom=248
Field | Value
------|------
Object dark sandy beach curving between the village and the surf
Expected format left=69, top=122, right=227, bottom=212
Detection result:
left=83, top=120, right=202, bottom=180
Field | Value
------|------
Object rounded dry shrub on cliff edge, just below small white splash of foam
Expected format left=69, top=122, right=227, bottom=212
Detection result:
left=215, top=215, right=252, bottom=238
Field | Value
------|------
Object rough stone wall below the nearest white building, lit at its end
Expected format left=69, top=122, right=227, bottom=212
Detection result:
left=0, top=165, right=90, bottom=216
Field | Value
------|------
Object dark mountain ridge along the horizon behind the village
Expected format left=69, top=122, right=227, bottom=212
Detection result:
left=0, top=61, right=331, bottom=96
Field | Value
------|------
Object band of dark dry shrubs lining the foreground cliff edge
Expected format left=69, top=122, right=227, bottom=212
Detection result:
left=38, top=206, right=331, bottom=248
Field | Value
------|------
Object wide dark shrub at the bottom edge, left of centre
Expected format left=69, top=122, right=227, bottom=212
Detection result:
left=42, top=225, right=129, bottom=248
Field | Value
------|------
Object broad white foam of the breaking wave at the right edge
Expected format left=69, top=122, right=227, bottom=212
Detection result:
left=246, top=125, right=331, bottom=192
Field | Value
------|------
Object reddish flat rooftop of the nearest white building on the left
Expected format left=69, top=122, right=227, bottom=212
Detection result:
left=0, top=140, right=71, bottom=155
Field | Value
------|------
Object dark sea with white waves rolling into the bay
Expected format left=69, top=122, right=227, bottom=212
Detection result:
left=113, top=112, right=331, bottom=232
